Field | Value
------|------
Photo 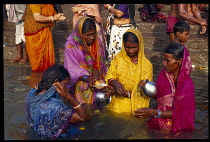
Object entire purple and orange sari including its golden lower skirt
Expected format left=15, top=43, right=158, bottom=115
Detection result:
left=64, top=17, right=107, bottom=103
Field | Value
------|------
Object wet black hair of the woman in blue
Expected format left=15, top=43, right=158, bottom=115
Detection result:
left=37, top=64, right=70, bottom=93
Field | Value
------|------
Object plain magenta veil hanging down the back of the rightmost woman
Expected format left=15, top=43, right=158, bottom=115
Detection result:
left=172, top=46, right=196, bottom=131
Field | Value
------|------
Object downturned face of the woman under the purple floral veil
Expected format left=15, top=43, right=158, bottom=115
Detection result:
left=82, top=29, right=96, bottom=46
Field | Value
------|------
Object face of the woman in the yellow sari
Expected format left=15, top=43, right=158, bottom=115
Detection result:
left=124, top=42, right=139, bottom=58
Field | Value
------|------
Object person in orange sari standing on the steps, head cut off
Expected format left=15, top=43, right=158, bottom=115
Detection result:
left=24, top=4, right=65, bottom=72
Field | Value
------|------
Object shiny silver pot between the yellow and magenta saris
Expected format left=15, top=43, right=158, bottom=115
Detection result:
left=141, top=80, right=157, bottom=97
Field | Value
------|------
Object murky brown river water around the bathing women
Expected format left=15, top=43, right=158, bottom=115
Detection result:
left=4, top=60, right=209, bottom=140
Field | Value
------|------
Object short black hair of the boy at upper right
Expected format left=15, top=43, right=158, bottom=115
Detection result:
left=174, top=21, right=190, bottom=35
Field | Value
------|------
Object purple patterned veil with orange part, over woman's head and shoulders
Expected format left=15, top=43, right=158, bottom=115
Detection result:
left=64, top=17, right=107, bottom=85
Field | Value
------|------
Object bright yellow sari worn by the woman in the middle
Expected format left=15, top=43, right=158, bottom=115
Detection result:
left=106, top=29, right=153, bottom=113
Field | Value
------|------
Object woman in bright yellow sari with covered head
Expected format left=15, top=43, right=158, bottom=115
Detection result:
left=105, top=29, right=153, bottom=114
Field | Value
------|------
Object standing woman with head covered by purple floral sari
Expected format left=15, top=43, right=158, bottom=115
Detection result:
left=64, top=17, right=107, bottom=104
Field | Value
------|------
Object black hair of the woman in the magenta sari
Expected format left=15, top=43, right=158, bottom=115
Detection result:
left=164, top=42, right=184, bottom=60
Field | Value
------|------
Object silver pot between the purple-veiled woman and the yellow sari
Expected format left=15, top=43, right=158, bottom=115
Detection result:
left=96, top=91, right=112, bottom=105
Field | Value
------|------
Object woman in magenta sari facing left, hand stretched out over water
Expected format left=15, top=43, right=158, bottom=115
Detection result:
left=135, top=42, right=195, bottom=134
